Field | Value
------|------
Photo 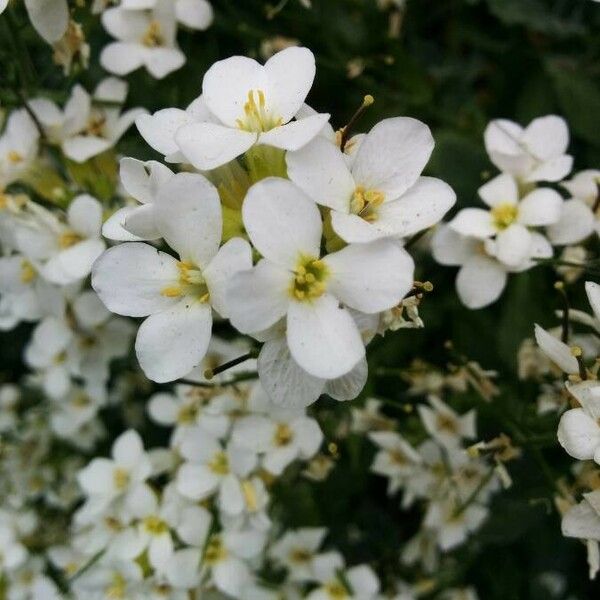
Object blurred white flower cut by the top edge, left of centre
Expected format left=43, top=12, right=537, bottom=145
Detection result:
left=100, top=0, right=185, bottom=79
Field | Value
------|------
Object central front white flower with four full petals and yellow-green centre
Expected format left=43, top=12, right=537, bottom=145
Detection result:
left=228, top=178, right=413, bottom=379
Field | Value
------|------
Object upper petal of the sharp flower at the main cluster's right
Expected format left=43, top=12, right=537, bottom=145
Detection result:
left=352, top=117, right=434, bottom=200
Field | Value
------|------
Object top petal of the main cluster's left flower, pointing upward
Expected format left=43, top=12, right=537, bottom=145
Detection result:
left=154, top=173, right=223, bottom=268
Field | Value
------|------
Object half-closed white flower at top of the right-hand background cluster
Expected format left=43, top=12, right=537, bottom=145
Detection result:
left=484, top=115, right=573, bottom=181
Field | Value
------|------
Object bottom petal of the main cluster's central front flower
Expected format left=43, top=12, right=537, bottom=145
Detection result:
left=287, top=294, right=365, bottom=379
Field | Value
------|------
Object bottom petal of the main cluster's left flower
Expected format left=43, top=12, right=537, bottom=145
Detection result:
left=135, top=298, right=212, bottom=383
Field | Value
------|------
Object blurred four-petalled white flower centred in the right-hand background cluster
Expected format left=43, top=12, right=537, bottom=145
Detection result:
left=450, top=174, right=563, bottom=268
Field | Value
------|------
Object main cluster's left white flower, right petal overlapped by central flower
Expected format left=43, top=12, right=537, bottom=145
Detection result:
left=92, top=173, right=252, bottom=382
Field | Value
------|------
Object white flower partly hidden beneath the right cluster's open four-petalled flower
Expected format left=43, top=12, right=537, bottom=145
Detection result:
left=431, top=225, right=552, bottom=309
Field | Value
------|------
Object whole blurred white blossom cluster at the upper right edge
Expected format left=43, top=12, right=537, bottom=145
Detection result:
left=431, top=115, right=600, bottom=309
